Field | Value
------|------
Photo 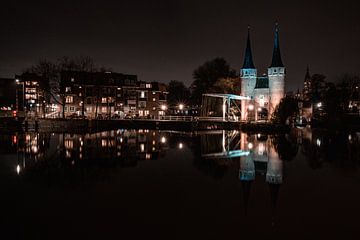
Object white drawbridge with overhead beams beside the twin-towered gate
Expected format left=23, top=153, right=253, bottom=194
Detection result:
left=199, top=93, right=251, bottom=122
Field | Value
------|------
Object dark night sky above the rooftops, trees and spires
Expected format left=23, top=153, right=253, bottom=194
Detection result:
left=0, top=0, right=360, bottom=90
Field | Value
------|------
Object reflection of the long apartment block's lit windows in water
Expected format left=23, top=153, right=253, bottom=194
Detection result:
left=59, top=130, right=167, bottom=165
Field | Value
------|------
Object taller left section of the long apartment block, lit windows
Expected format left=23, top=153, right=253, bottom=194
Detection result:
left=60, top=71, right=137, bottom=118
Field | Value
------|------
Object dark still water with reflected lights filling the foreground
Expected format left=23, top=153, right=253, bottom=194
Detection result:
left=0, top=129, right=360, bottom=239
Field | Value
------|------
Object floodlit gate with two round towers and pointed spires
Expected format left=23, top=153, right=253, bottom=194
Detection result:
left=240, top=24, right=285, bottom=121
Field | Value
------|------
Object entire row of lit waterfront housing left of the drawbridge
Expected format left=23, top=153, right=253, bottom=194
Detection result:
left=0, top=71, right=168, bottom=118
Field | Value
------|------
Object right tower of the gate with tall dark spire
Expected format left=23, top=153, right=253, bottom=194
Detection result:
left=268, top=24, right=285, bottom=115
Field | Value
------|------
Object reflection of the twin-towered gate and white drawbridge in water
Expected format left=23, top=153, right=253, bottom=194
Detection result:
left=201, top=131, right=282, bottom=184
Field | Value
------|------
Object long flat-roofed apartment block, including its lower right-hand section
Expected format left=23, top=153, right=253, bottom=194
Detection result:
left=60, top=71, right=167, bottom=118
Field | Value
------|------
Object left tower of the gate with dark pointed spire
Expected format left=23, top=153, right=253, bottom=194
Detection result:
left=240, top=28, right=257, bottom=120
